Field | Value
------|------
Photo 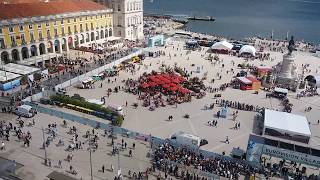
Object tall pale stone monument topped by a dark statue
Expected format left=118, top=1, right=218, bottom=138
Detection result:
left=276, top=36, right=298, bottom=89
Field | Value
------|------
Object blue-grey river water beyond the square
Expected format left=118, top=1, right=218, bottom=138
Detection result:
left=144, top=0, right=320, bottom=44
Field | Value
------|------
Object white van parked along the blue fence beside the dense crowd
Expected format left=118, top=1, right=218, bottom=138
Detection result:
left=171, top=131, right=201, bottom=148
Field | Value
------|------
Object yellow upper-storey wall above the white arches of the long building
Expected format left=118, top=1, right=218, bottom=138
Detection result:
left=2, top=13, right=112, bottom=48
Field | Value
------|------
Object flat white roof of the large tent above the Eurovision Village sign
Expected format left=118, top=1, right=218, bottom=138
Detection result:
left=264, top=109, right=311, bottom=138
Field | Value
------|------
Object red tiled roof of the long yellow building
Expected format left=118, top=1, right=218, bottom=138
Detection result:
left=0, top=0, right=106, bottom=20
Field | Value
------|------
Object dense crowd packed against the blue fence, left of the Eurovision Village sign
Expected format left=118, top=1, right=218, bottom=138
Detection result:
left=153, top=142, right=259, bottom=179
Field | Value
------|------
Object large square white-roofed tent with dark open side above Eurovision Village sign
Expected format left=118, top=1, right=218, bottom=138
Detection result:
left=263, top=109, right=311, bottom=144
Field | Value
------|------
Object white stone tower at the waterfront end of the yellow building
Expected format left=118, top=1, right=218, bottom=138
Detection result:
left=94, top=0, right=144, bottom=40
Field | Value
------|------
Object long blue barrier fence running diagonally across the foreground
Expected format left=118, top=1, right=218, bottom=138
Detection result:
left=25, top=101, right=254, bottom=179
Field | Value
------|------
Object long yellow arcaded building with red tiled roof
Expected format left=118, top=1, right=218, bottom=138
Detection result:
left=0, top=0, right=113, bottom=66
